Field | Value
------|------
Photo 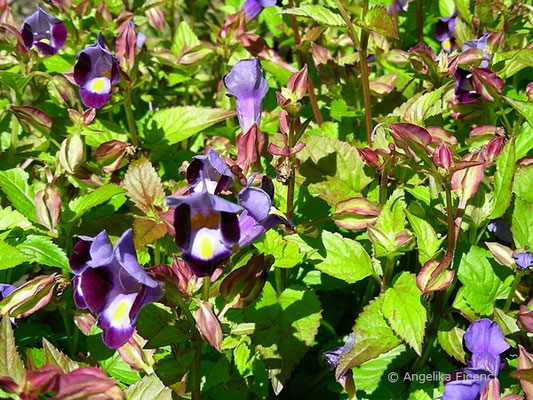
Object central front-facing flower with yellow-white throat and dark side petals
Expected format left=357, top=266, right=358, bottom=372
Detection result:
left=167, top=191, right=242, bottom=277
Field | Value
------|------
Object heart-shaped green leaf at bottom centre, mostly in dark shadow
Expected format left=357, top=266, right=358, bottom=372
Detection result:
left=245, top=282, right=321, bottom=395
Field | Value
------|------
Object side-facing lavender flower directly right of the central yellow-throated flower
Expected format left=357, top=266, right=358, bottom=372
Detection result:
left=239, top=176, right=294, bottom=248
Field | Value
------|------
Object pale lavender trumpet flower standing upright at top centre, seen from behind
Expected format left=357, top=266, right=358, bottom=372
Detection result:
left=224, top=58, right=268, bottom=134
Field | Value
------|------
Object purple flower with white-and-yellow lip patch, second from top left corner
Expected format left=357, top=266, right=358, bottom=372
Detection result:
left=74, top=33, right=119, bottom=108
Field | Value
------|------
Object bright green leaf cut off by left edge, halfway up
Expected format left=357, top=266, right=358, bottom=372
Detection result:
left=0, top=168, right=37, bottom=222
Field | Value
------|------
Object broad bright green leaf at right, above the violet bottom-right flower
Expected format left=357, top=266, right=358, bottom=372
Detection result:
left=457, top=246, right=513, bottom=315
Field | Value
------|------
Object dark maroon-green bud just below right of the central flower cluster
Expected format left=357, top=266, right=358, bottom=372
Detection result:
left=220, top=254, right=274, bottom=308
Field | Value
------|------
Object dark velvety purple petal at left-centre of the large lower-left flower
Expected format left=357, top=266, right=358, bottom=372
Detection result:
left=78, top=267, right=112, bottom=314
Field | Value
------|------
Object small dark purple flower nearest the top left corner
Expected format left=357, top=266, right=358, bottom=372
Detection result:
left=20, top=6, right=67, bottom=55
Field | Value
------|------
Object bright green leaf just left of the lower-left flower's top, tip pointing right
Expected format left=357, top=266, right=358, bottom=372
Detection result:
left=17, top=235, right=70, bottom=272
